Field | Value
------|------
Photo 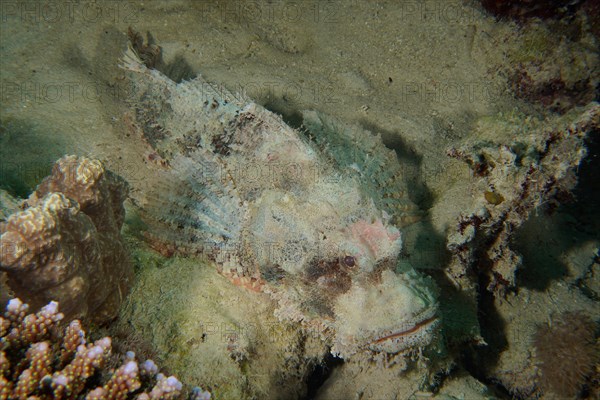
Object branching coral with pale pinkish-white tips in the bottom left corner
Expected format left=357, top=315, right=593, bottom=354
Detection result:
left=0, top=298, right=210, bottom=400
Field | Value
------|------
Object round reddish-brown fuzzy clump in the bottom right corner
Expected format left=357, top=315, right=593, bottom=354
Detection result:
left=534, top=313, right=600, bottom=398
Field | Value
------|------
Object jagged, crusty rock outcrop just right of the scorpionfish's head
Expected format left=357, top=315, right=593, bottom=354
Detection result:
left=447, top=103, right=600, bottom=292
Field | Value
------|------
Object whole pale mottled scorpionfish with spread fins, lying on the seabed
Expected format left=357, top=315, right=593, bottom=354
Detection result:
left=122, top=44, right=438, bottom=358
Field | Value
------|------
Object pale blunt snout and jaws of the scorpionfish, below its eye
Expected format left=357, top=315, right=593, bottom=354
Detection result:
left=332, top=269, right=439, bottom=358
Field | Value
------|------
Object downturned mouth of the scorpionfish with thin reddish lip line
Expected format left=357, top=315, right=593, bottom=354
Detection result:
left=368, top=312, right=439, bottom=352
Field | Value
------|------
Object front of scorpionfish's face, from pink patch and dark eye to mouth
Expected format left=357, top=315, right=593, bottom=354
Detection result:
left=305, top=219, right=439, bottom=358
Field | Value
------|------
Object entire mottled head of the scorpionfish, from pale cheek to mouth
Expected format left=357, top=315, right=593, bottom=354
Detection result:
left=246, top=195, right=438, bottom=358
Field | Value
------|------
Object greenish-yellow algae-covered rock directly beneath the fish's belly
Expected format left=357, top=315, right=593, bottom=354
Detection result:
left=119, top=253, right=328, bottom=399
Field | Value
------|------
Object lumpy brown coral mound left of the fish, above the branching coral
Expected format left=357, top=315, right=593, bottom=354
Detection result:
left=0, top=156, right=133, bottom=323
